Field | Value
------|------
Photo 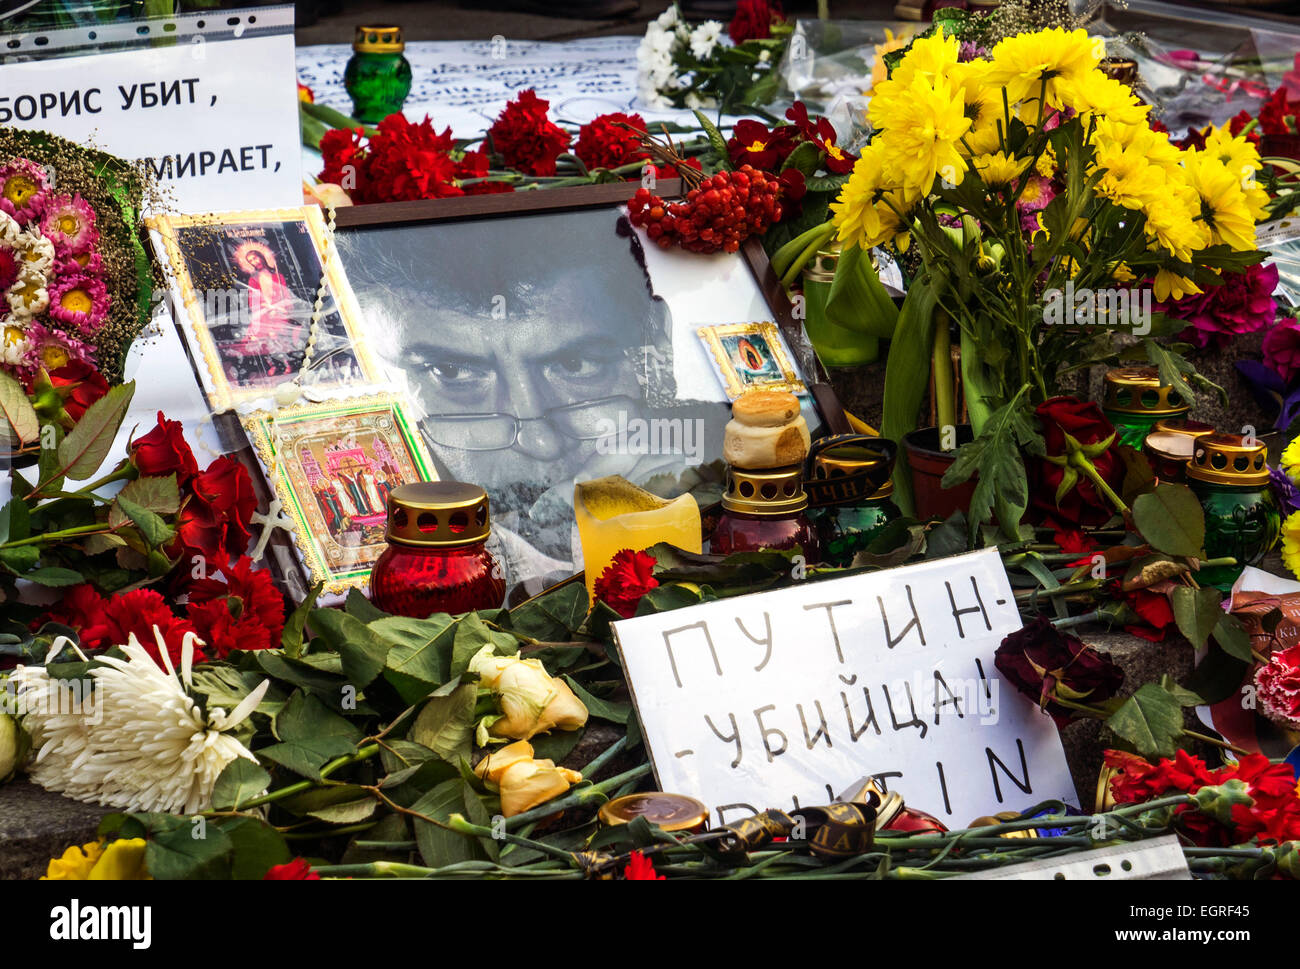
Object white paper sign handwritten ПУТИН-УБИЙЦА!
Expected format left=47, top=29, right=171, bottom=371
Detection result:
left=614, top=549, right=1076, bottom=826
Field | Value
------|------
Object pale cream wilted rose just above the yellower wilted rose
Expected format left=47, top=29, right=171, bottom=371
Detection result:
left=469, top=646, right=586, bottom=740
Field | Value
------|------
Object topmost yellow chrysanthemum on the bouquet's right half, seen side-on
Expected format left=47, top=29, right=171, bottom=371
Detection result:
left=988, top=27, right=1102, bottom=108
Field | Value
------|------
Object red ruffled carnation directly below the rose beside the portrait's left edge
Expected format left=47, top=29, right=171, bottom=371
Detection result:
left=189, top=555, right=285, bottom=659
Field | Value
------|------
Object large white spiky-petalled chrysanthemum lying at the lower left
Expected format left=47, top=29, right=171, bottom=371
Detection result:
left=13, top=627, right=270, bottom=814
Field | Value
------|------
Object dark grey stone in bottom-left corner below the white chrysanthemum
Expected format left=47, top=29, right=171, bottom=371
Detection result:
left=0, top=780, right=109, bottom=879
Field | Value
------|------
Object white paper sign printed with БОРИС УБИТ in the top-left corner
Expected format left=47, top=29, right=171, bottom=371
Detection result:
left=0, top=12, right=303, bottom=213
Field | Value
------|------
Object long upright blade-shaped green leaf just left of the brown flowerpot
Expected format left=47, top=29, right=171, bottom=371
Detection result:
left=880, top=280, right=937, bottom=515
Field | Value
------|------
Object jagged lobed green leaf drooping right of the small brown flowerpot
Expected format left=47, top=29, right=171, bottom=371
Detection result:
left=943, top=384, right=1044, bottom=535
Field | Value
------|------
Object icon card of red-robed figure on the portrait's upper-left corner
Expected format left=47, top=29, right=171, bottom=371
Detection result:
left=150, top=206, right=374, bottom=411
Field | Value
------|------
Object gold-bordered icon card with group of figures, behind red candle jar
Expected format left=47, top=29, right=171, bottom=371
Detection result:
left=243, top=395, right=437, bottom=594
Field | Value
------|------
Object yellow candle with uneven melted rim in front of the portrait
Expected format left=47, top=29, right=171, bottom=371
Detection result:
left=573, top=475, right=703, bottom=597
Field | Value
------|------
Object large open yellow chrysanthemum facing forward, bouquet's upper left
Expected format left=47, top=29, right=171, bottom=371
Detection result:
left=870, top=77, right=971, bottom=195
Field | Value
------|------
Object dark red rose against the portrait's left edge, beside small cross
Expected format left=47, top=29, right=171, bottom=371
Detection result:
left=173, top=455, right=257, bottom=572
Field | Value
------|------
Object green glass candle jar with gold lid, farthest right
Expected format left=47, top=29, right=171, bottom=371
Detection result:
left=1187, top=434, right=1282, bottom=592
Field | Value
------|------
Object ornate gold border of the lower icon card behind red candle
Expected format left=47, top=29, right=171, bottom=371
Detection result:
left=239, top=394, right=437, bottom=596
